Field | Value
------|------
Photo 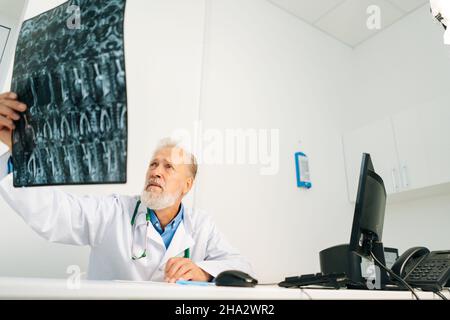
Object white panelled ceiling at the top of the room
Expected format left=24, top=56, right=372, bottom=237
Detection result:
left=267, top=0, right=429, bottom=48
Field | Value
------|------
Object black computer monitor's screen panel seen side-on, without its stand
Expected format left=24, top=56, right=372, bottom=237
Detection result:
left=349, top=153, right=386, bottom=261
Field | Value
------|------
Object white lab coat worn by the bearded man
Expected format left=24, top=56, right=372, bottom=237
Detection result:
left=0, top=174, right=252, bottom=281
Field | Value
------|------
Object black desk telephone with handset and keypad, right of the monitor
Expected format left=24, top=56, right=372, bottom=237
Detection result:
left=391, top=247, right=450, bottom=291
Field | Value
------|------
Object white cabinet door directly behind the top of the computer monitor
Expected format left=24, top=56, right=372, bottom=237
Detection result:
left=343, top=118, right=400, bottom=202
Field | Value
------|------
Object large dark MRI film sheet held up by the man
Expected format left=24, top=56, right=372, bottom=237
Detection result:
left=11, top=0, right=127, bottom=187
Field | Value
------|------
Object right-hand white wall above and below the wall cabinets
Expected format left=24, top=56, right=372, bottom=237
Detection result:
left=350, top=5, right=450, bottom=255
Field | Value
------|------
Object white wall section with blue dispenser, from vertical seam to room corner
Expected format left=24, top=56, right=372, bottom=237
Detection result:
left=196, top=0, right=353, bottom=282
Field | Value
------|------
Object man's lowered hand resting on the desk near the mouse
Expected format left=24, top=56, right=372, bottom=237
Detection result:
left=165, top=258, right=212, bottom=283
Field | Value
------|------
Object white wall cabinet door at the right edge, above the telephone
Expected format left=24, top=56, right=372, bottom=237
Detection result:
left=393, top=100, right=450, bottom=190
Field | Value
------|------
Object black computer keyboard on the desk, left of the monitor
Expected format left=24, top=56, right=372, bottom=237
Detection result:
left=278, top=273, right=349, bottom=289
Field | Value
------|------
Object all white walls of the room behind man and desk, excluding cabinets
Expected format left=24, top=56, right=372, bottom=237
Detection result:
left=0, top=0, right=450, bottom=282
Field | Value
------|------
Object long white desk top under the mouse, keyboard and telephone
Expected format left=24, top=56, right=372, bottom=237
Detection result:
left=0, top=277, right=450, bottom=300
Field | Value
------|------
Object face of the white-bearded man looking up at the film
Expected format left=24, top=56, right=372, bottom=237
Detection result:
left=143, top=147, right=193, bottom=210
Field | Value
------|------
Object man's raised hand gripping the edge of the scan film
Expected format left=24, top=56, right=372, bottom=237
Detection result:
left=0, top=92, right=27, bottom=149
